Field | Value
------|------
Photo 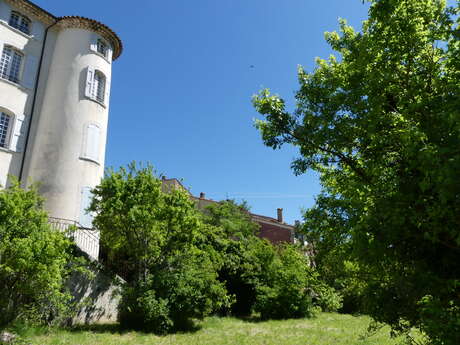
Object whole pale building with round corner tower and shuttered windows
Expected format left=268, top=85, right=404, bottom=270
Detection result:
left=0, top=0, right=122, bottom=258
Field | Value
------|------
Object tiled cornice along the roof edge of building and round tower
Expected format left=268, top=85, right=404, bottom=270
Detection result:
left=5, top=0, right=123, bottom=60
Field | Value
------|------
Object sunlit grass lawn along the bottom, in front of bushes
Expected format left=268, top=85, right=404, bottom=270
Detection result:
left=18, top=313, right=416, bottom=345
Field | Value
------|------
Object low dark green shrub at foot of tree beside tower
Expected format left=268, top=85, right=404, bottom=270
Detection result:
left=119, top=250, right=229, bottom=334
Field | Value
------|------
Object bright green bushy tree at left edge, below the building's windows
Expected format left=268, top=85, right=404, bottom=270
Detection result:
left=0, top=182, right=70, bottom=327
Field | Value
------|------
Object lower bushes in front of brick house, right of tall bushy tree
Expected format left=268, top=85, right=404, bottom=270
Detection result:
left=204, top=201, right=340, bottom=319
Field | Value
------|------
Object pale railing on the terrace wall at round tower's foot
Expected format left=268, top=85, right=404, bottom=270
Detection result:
left=49, top=217, right=100, bottom=260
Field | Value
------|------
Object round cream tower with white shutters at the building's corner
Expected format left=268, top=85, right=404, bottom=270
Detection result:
left=25, top=17, right=122, bottom=228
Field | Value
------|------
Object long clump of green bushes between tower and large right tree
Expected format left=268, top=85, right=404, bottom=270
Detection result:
left=91, top=163, right=340, bottom=334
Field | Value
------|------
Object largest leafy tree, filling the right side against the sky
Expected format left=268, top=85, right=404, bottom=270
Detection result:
left=254, top=0, right=460, bottom=344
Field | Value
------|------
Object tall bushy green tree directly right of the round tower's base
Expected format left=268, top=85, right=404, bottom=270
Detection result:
left=90, top=163, right=228, bottom=333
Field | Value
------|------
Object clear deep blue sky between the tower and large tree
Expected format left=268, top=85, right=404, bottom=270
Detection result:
left=33, top=0, right=368, bottom=223
